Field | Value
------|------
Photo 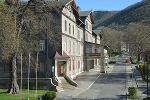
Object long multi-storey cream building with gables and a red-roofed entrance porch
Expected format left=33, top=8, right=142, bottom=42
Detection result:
left=0, top=0, right=107, bottom=89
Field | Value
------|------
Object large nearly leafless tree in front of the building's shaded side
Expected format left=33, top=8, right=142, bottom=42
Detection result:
left=0, top=0, right=61, bottom=94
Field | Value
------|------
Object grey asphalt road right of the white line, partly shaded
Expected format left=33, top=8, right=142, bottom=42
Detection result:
left=72, top=64, right=127, bottom=100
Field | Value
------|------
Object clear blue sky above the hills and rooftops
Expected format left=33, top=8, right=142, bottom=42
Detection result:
left=75, top=0, right=142, bottom=11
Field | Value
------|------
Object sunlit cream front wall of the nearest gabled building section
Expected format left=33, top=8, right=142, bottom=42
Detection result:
left=62, top=3, right=83, bottom=78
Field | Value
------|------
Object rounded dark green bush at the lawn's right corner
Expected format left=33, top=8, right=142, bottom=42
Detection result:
left=42, top=91, right=56, bottom=100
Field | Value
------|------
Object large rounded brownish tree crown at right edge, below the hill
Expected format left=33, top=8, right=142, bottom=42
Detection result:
left=123, top=23, right=150, bottom=55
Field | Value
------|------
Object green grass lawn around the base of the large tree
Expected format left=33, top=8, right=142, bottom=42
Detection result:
left=0, top=89, right=48, bottom=100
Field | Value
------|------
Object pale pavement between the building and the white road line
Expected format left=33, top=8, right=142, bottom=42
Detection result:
left=54, top=65, right=114, bottom=100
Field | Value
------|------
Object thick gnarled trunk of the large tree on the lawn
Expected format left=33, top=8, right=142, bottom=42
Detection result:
left=8, top=55, right=19, bottom=94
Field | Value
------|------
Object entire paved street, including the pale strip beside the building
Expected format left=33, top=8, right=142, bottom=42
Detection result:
left=55, top=57, right=131, bottom=100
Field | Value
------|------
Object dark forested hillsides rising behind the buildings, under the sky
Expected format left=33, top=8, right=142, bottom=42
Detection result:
left=93, top=0, right=150, bottom=29
